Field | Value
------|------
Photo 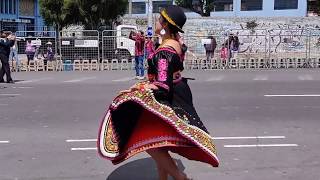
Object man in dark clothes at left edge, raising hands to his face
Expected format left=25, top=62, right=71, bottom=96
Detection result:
left=0, top=30, right=15, bottom=83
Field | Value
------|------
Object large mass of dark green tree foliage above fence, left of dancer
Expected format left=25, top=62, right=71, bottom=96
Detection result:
left=40, top=0, right=128, bottom=29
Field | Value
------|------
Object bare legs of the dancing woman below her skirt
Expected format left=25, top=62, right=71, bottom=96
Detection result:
left=147, top=148, right=187, bottom=180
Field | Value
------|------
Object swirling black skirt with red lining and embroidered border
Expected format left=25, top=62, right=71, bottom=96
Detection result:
left=97, top=81, right=219, bottom=167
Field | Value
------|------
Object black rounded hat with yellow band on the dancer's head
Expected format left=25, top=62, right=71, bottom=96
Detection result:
left=160, top=5, right=187, bottom=33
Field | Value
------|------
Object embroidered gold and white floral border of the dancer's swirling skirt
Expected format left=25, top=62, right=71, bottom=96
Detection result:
left=100, top=82, right=219, bottom=166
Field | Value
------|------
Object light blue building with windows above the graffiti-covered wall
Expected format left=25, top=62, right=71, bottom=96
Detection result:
left=127, top=0, right=308, bottom=17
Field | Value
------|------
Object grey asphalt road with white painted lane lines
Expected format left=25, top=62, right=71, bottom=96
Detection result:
left=0, top=69, right=320, bottom=180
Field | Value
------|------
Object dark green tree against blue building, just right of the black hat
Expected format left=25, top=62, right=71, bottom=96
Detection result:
left=175, top=0, right=214, bottom=16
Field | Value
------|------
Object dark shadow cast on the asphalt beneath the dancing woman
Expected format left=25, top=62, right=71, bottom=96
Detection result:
left=107, top=158, right=185, bottom=180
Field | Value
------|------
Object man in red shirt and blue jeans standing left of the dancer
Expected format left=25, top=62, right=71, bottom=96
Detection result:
left=129, top=31, right=145, bottom=80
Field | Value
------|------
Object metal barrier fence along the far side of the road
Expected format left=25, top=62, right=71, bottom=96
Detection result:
left=8, top=28, right=320, bottom=70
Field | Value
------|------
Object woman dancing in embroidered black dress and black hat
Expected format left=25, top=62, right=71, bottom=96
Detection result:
left=98, top=5, right=219, bottom=180
